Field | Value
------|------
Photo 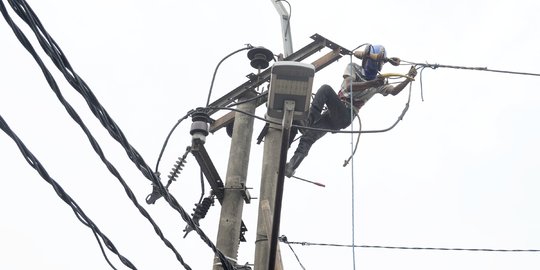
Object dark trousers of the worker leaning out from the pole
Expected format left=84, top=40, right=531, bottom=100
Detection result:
left=294, top=84, right=351, bottom=156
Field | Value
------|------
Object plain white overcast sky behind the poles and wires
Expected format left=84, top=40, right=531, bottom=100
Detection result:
left=0, top=0, right=540, bottom=270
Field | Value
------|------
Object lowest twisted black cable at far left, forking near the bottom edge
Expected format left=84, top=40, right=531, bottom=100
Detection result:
left=0, top=113, right=137, bottom=269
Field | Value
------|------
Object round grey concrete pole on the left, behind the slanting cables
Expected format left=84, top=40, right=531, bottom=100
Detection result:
left=213, top=92, right=257, bottom=270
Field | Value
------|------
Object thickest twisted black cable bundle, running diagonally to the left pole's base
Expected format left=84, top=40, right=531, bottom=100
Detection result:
left=6, top=0, right=234, bottom=270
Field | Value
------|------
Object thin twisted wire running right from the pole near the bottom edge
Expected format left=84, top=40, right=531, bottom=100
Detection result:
left=279, top=236, right=540, bottom=252
